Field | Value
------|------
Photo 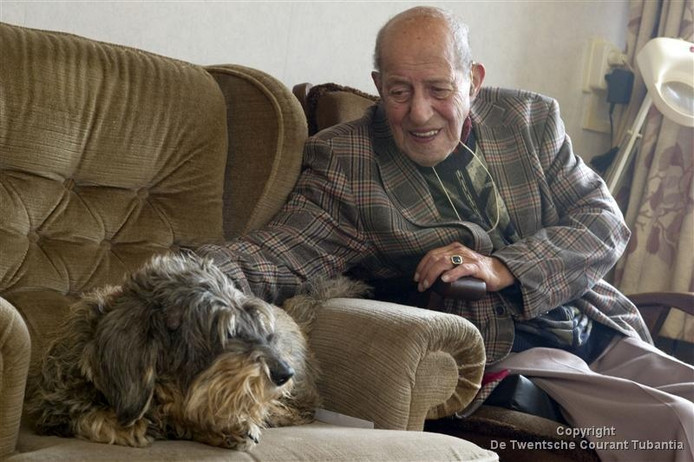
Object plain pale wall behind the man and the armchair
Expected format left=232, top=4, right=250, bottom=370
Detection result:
left=0, top=0, right=628, bottom=159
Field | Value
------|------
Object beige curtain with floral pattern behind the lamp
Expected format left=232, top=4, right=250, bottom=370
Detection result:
left=613, top=0, right=694, bottom=341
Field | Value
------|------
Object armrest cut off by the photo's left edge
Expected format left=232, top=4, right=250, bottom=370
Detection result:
left=0, top=297, right=31, bottom=460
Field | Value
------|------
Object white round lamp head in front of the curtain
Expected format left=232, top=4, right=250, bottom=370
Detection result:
left=636, top=37, right=694, bottom=127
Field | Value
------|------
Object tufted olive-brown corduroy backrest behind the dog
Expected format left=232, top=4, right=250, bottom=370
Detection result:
left=0, top=24, right=227, bottom=370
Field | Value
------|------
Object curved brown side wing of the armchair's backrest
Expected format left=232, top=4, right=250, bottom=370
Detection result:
left=206, top=64, right=307, bottom=239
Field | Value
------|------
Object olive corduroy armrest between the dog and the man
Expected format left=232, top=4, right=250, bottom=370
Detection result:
left=309, top=298, right=485, bottom=430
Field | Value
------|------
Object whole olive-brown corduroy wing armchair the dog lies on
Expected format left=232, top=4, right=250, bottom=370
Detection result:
left=0, top=24, right=497, bottom=462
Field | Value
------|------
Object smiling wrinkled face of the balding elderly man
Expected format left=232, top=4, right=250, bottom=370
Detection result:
left=373, top=22, right=483, bottom=167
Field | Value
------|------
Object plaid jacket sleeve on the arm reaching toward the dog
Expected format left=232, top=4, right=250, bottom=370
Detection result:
left=197, top=139, right=370, bottom=303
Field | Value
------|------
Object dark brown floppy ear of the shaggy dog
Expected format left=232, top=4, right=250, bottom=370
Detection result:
left=93, top=300, right=159, bottom=426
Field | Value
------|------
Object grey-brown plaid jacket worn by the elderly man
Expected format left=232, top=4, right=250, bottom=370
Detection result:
left=200, top=88, right=650, bottom=363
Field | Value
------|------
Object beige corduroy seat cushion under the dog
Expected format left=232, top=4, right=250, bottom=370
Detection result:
left=6, top=422, right=498, bottom=462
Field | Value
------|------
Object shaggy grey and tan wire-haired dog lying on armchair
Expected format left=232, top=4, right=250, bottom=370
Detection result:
left=30, top=254, right=360, bottom=450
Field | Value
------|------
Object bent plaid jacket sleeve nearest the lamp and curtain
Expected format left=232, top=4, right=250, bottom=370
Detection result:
left=494, top=100, right=630, bottom=319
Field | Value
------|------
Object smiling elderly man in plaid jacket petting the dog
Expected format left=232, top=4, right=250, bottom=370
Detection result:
left=201, top=7, right=694, bottom=461
